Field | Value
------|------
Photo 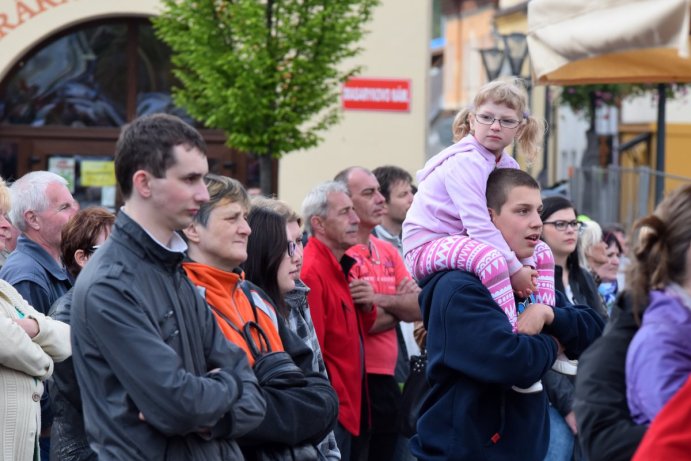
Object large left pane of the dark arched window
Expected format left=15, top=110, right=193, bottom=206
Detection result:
left=2, top=24, right=127, bottom=127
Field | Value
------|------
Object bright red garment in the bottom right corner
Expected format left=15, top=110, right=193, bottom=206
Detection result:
left=632, top=379, right=691, bottom=461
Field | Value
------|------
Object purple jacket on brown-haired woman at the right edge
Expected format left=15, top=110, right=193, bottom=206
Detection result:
left=626, top=285, right=691, bottom=424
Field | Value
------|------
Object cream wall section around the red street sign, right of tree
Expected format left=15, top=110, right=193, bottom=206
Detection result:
left=278, top=0, right=431, bottom=209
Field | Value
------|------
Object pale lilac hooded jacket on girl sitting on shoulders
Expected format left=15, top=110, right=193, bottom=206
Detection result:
left=403, top=135, right=523, bottom=274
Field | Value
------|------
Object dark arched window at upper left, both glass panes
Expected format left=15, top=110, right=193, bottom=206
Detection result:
left=0, top=20, right=197, bottom=128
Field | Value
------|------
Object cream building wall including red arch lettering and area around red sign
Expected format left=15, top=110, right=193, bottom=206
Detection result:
left=0, top=0, right=431, bottom=212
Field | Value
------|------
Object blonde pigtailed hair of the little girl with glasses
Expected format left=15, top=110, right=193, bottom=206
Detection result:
left=451, top=77, right=545, bottom=162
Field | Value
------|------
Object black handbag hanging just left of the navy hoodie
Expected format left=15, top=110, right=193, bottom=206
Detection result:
left=400, top=350, right=430, bottom=438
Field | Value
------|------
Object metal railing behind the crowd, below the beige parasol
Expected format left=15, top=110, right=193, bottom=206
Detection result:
left=568, top=165, right=691, bottom=227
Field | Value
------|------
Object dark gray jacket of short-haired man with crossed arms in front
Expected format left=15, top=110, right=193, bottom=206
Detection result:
left=72, top=212, right=266, bottom=461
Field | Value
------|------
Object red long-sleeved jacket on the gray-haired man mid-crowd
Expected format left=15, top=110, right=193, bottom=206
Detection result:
left=301, top=237, right=376, bottom=436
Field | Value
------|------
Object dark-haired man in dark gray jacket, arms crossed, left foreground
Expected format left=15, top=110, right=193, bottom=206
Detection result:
left=72, top=114, right=265, bottom=461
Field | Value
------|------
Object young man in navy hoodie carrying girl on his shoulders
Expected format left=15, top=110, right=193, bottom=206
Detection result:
left=411, top=169, right=603, bottom=461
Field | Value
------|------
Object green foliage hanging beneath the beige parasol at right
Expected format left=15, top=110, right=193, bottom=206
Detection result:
left=561, top=83, right=687, bottom=120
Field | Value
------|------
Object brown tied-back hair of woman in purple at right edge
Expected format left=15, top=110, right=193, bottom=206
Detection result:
left=626, top=186, right=691, bottom=321
